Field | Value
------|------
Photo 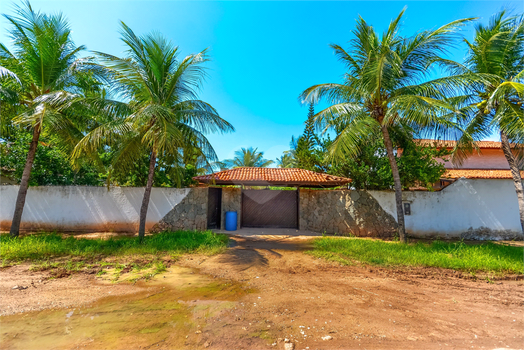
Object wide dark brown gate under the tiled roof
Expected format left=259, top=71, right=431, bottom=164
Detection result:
left=242, top=190, right=298, bottom=228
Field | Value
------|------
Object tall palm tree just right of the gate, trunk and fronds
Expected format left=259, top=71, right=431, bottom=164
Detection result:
left=300, top=10, right=470, bottom=242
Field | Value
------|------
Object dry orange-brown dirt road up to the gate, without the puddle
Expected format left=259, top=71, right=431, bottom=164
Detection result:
left=0, top=237, right=524, bottom=350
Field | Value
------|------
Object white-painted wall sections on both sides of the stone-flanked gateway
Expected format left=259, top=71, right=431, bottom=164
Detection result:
left=0, top=179, right=522, bottom=239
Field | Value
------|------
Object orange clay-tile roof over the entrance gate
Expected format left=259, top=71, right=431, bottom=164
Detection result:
left=193, top=167, right=351, bottom=187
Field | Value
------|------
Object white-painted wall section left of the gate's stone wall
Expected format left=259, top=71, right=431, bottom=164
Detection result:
left=0, top=186, right=190, bottom=232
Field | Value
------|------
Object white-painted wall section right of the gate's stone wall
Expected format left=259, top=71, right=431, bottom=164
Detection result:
left=369, top=179, right=522, bottom=239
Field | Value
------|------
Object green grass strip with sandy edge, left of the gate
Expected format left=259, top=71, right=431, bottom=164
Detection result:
left=0, top=231, right=229, bottom=282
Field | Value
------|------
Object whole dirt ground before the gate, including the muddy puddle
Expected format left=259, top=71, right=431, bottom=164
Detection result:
left=0, top=237, right=524, bottom=350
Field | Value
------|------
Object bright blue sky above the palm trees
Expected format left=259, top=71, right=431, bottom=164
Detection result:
left=0, top=0, right=524, bottom=160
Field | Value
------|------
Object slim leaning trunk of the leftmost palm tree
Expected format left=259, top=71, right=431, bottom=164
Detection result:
left=9, top=124, right=41, bottom=237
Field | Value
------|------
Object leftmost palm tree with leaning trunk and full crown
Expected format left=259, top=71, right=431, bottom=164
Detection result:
left=0, top=2, right=94, bottom=236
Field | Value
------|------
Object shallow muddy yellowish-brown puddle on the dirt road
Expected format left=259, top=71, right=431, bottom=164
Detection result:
left=0, top=267, right=250, bottom=350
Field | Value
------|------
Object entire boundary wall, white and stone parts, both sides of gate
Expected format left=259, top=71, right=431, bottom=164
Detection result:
left=0, top=179, right=522, bottom=239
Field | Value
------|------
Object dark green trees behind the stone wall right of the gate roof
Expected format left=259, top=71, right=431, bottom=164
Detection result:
left=277, top=110, right=450, bottom=190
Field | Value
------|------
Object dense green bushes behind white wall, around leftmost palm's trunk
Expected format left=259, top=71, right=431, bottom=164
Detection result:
left=0, top=128, right=103, bottom=186
